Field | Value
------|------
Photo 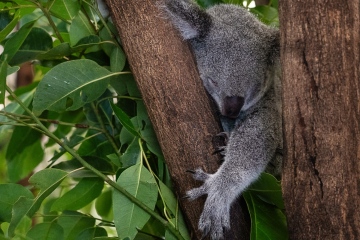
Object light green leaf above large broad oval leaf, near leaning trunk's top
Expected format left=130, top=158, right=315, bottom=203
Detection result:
left=69, top=11, right=96, bottom=46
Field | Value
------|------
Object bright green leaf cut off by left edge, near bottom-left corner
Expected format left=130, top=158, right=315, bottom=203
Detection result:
left=0, top=183, right=34, bottom=222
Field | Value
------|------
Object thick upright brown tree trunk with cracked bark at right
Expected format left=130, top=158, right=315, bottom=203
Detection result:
left=279, top=0, right=360, bottom=240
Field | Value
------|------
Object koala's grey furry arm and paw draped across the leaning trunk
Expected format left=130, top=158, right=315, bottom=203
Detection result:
left=187, top=110, right=278, bottom=239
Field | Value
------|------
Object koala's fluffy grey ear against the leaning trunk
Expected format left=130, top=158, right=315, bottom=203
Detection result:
left=164, top=0, right=211, bottom=40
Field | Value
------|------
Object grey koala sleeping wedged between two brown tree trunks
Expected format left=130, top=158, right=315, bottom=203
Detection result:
left=164, top=0, right=282, bottom=239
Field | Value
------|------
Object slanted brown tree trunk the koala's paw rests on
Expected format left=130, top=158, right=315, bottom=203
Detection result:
left=107, top=0, right=249, bottom=239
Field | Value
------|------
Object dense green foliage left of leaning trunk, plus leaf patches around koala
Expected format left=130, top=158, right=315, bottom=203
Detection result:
left=0, top=0, right=286, bottom=240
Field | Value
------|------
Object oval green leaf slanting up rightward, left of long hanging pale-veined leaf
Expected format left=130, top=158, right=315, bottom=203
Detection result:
left=51, top=178, right=104, bottom=211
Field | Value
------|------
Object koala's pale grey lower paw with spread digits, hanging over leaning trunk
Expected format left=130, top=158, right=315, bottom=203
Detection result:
left=186, top=169, right=230, bottom=240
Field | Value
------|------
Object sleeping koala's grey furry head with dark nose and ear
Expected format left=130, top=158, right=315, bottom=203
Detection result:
left=165, top=0, right=279, bottom=118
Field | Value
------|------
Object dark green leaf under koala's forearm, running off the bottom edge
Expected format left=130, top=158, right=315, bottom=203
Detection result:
left=243, top=191, right=288, bottom=240
